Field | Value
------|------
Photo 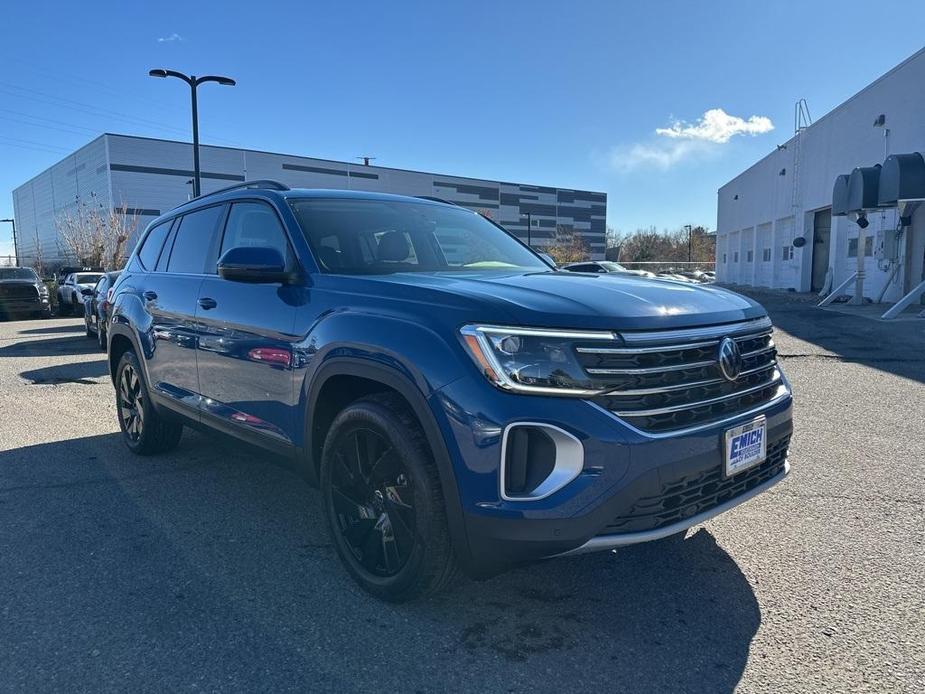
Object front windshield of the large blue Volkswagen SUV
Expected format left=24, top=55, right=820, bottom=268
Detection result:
left=290, top=198, right=549, bottom=274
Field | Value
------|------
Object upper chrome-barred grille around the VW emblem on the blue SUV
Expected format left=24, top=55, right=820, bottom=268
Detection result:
left=576, top=318, right=784, bottom=433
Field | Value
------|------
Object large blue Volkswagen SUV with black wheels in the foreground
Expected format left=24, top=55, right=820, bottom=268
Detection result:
left=109, top=182, right=791, bottom=600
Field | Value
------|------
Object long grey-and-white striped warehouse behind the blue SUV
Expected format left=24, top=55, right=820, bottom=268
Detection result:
left=13, top=133, right=607, bottom=264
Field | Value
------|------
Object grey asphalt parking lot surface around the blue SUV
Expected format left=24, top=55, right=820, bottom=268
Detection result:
left=0, top=293, right=925, bottom=692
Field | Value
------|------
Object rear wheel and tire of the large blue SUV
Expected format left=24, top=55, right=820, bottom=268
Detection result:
left=116, top=350, right=183, bottom=455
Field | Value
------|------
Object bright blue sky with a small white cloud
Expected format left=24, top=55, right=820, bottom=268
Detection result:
left=0, top=0, right=925, bottom=254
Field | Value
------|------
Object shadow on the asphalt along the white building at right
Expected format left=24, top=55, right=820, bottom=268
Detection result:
left=733, top=287, right=925, bottom=383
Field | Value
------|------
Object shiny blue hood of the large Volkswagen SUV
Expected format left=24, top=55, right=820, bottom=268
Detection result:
left=358, top=271, right=765, bottom=329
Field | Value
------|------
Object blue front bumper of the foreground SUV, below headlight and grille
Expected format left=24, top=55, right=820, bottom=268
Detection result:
left=430, top=381, right=792, bottom=576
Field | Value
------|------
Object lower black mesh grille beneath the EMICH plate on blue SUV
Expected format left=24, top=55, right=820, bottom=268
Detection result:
left=600, top=436, right=790, bottom=535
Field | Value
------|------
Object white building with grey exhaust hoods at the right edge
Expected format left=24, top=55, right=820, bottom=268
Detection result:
left=716, top=49, right=925, bottom=310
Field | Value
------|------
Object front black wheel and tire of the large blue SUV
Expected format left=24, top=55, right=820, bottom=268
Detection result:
left=321, top=394, right=456, bottom=602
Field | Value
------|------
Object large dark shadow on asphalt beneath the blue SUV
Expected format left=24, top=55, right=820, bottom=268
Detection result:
left=0, top=431, right=761, bottom=692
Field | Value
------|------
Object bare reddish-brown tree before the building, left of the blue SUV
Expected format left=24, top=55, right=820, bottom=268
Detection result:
left=56, top=194, right=138, bottom=270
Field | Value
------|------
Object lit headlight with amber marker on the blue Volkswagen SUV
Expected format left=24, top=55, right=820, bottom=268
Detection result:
left=460, top=325, right=617, bottom=397
